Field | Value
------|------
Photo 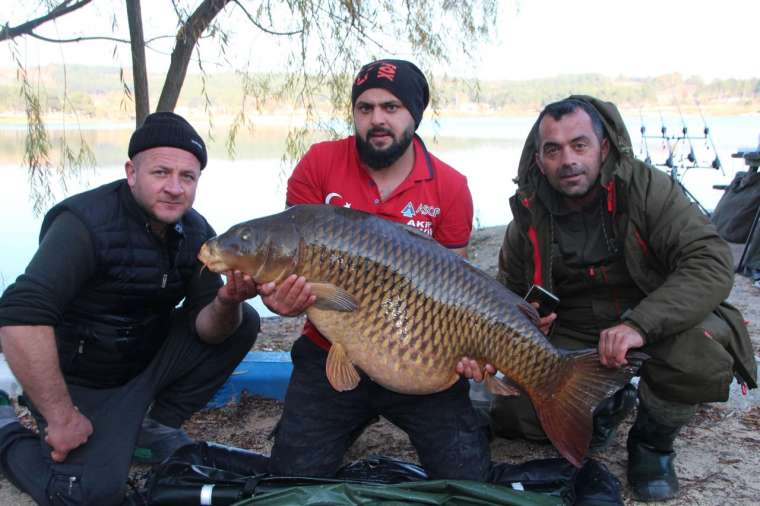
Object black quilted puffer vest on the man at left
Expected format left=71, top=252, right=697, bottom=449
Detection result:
left=40, top=180, right=213, bottom=388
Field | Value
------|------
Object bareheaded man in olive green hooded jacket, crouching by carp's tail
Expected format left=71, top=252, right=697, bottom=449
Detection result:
left=464, top=96, right=757, bottom=500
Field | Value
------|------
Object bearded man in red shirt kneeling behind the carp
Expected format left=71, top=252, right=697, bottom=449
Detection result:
left=259, top=60, right=490, bottom=481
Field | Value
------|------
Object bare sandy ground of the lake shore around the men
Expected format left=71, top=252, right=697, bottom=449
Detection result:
left=0, top=227, right=760, bottom=506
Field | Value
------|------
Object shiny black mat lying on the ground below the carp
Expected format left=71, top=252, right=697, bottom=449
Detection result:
left=138, top=442, right=623, bottom=506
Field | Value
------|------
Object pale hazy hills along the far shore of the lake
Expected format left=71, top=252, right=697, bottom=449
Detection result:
left=0, top=65, right=760, bottom=122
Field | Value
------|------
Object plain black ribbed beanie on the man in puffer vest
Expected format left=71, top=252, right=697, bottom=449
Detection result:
left=127, top=112, right=208, bottom=170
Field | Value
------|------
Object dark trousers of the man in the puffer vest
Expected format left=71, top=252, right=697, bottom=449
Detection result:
left=0, top=304, right=259, bottom=506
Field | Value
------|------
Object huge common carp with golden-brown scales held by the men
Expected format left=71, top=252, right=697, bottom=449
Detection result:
left=198, top=205, right=642, bottom=466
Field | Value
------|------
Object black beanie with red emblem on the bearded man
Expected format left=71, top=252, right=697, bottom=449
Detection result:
left=351, top=60, right=430, bottom=130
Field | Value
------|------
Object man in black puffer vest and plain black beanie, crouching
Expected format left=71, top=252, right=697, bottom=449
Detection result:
left=0, top=112, right=259, bottom=505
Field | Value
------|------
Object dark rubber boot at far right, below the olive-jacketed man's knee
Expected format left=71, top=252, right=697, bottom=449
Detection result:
left=628, top=404, right=681, bottom=502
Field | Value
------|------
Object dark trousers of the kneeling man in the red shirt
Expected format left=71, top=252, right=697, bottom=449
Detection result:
left=270, top=336, right=491, bottom=481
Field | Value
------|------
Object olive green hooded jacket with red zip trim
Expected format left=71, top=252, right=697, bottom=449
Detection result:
left=498, top=96, right=757, bottom=387
